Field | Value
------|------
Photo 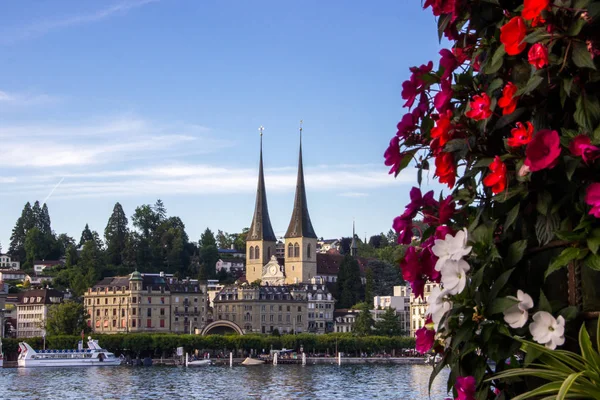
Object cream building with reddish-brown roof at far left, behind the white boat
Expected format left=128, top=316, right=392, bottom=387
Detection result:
left=17, top=289, right=64, bottom=338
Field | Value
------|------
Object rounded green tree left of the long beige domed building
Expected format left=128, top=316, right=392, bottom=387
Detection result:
left=45, top=301, right=90, bottom=336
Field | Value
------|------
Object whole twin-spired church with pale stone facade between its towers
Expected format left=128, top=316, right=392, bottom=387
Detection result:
left=246, top=128, right=317, bottom=285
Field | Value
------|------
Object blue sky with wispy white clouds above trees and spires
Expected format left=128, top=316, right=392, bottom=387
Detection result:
left=0, top=0, right=440, bottom=250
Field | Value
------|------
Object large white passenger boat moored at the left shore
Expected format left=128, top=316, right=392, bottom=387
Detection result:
left=17, top=338, right=121, bottom=368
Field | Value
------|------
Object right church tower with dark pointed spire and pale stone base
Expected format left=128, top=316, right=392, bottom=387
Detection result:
left=285, top=122, right=317, bottom=284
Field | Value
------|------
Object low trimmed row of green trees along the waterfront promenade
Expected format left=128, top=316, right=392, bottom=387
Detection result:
left=3, top=333, right=415, bottom=358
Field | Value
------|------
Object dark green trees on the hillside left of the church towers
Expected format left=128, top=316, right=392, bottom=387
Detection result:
left=8, top=199, right=247, bottom=296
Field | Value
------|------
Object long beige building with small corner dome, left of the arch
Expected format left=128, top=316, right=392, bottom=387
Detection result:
left=84, top=271, right=207, bottom=333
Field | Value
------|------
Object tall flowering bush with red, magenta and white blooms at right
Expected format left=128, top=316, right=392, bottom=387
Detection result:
left=384, top=0, right=600, bottom=399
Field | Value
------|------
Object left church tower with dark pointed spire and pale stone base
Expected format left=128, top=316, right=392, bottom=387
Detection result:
left=246, top=126, right=277, bottom=283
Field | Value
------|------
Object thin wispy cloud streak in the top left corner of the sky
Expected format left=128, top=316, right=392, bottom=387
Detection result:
left=0, top=0, right=159, bottom=45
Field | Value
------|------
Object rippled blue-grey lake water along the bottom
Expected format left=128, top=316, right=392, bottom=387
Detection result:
left=0, top=364, right=447, bottom=400
